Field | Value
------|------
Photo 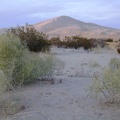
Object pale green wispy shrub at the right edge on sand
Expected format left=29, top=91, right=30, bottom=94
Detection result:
left=89, top=58, right=120, bottom=103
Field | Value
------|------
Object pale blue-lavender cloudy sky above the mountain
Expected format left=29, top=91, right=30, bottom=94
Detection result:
left=0, top=0, right=120, bottom=29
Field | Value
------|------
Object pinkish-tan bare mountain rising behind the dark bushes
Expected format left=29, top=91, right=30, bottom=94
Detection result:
left=33, top=16, right=120, bottom=40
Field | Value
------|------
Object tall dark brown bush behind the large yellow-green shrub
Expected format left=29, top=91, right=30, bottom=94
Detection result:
left=7, top=24, right=50, bottom=52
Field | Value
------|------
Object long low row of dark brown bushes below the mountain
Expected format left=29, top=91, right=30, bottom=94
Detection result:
left=49, top=35, right=111, bottom=50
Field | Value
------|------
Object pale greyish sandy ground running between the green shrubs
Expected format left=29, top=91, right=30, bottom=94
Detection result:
left=0, top=48, right=120, bottom=120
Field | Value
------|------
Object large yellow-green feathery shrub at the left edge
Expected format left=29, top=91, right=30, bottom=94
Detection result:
left=0, top=35, right=53, bottom=86
